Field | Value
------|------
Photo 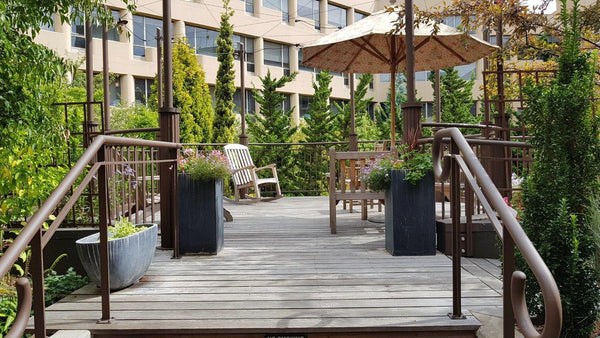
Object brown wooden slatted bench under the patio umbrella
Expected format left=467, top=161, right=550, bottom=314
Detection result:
left=328, top=147, right=391, bottom=234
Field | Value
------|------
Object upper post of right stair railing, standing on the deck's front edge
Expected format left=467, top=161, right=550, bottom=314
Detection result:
left=450, top=140, right=463, bottom=319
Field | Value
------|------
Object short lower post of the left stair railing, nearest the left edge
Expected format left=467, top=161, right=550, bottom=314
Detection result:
left=29, top=227, right=46, bottom=337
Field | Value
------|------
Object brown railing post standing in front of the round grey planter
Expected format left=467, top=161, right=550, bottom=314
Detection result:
left=97, top=146, right=111, bottom=323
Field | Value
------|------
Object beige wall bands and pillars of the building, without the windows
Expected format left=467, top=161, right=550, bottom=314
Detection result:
left=36, top=0, right=496, bottom=123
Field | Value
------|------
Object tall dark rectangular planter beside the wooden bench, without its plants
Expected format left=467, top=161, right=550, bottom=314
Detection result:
left=385, top=170, right=436, bottom=256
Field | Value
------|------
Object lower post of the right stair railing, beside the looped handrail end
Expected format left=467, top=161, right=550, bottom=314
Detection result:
left=502, top=225, right=515, bottom=338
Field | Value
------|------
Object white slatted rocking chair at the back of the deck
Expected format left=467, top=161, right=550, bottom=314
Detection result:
left=225, top=144, right=283, bottom=201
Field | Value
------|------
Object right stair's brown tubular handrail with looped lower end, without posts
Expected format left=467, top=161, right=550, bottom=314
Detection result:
left=433, top=128, right=562, bottom=338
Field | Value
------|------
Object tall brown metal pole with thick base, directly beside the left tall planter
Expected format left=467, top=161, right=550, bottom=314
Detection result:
left=158, top=0, right=179, bottom=251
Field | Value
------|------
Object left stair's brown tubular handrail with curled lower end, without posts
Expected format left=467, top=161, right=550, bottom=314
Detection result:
left=0, top=135, right=181, bottom=337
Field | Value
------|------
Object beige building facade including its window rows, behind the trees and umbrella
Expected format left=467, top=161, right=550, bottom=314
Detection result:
left=36, top=0, right=492, bottom=123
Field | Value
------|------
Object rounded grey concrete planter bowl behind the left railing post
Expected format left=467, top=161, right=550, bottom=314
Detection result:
left=75, top=224, right=158, bottom=290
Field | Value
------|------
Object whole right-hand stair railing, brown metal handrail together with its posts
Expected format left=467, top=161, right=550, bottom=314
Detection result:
left=433, top=128, right=562, bottom=338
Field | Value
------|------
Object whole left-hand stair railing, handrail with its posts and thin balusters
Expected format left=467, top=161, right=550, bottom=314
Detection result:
left=0, top=135, right=181, bottom=337
